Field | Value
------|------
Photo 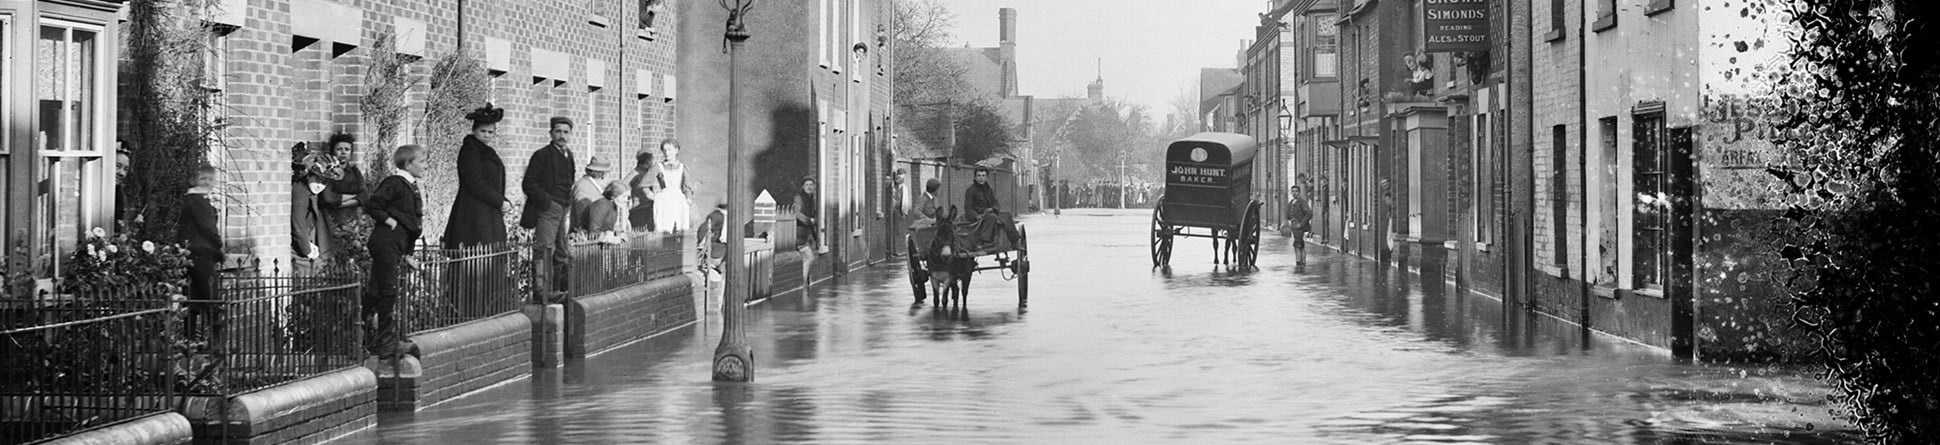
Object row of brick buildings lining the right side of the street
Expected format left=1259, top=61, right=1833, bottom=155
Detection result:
left=1290, top=0, right=1796, bottom=359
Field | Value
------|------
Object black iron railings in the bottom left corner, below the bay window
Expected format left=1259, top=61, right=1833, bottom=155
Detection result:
left=0, top=286, right=178, bottom=443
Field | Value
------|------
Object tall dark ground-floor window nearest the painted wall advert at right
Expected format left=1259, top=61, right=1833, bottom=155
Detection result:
left=1632, top=113, right=1670, bottom=290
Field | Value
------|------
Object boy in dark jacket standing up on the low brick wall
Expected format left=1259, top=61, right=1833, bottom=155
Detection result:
left=363, top=144, right=425, bottom=358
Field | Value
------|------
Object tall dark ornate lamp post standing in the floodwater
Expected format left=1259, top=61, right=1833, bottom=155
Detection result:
left=714, top=0, right=757, bottom=381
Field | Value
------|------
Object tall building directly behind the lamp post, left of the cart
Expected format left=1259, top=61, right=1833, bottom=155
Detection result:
left=677, top=0, right=896, bottom=274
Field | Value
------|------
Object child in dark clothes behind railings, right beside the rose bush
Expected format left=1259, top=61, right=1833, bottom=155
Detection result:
left=175, top=165, right=223, bottom=336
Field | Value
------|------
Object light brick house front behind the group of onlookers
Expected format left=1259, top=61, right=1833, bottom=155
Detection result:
left=75, top=0, right=695, bottom=268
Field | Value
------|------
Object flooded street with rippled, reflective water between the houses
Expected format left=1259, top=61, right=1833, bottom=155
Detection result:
left=360, top=210, right=1857, bottom=443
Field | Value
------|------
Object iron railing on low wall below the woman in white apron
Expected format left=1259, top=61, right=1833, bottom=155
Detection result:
left=566, top=233, right=695, bottom=297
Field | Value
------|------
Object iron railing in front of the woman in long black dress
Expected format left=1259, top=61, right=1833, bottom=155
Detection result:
left=396, top=243, right=535, bottom=334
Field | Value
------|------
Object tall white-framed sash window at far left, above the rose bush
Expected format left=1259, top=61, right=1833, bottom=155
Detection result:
left=33, top=21, right=109, bottom=276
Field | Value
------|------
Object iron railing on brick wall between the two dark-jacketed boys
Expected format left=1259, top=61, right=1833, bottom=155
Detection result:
left=182, top=268, right=365, bottom=396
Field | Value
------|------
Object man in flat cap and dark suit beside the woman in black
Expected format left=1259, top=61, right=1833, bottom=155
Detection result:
left=518, top=117, right=572, bottom=301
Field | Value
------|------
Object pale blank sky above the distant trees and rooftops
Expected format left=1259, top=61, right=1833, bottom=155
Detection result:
left=943, top=0, right=1271, bottom=119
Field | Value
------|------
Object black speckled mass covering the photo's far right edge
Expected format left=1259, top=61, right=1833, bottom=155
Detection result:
left=1777, top=0, right=1940, bottom=443
